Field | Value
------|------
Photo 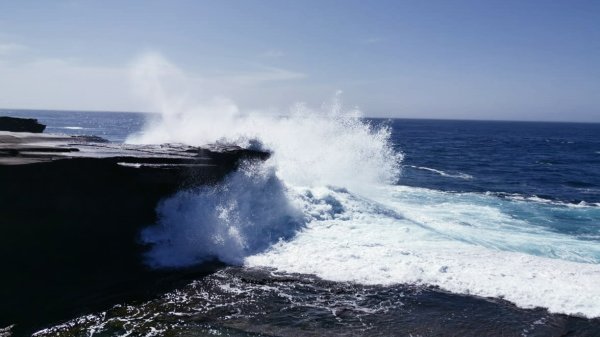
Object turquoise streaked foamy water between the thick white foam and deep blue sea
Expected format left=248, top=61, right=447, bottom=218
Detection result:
left=370, top=186, right=600, bottom=263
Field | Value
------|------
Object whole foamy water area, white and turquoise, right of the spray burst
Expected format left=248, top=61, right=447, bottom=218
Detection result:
left=246, top=187, right=600, bottom=317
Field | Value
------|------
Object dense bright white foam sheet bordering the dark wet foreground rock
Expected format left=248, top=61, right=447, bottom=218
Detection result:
left=246, top=188, right=600, bottom=317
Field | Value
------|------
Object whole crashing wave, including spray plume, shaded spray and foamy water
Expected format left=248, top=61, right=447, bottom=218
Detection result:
left=127, top=55, right=600, bottom=317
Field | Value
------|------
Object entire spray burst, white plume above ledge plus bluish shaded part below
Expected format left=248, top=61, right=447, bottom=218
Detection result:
left=132, top=55, right=402, bottom=267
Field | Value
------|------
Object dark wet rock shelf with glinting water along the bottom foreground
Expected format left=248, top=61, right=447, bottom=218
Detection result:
left=30, top=267, right=600, bottom=337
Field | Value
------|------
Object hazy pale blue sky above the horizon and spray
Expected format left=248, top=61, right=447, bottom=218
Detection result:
left=0, top=0, right=600, bottom=122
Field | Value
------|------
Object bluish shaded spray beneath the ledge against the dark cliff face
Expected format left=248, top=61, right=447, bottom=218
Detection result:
left=142, top=163, right=304, bottom=267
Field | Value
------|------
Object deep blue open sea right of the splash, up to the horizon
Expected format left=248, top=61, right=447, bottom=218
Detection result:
left=391, top=119, right=600, bottom=204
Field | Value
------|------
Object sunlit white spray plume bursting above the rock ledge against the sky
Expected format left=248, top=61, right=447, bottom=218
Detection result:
left=127, top=55, right=402, bottom=190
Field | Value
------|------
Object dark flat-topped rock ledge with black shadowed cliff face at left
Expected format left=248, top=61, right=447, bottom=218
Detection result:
left=0, top=132, right=269, bottom=335
